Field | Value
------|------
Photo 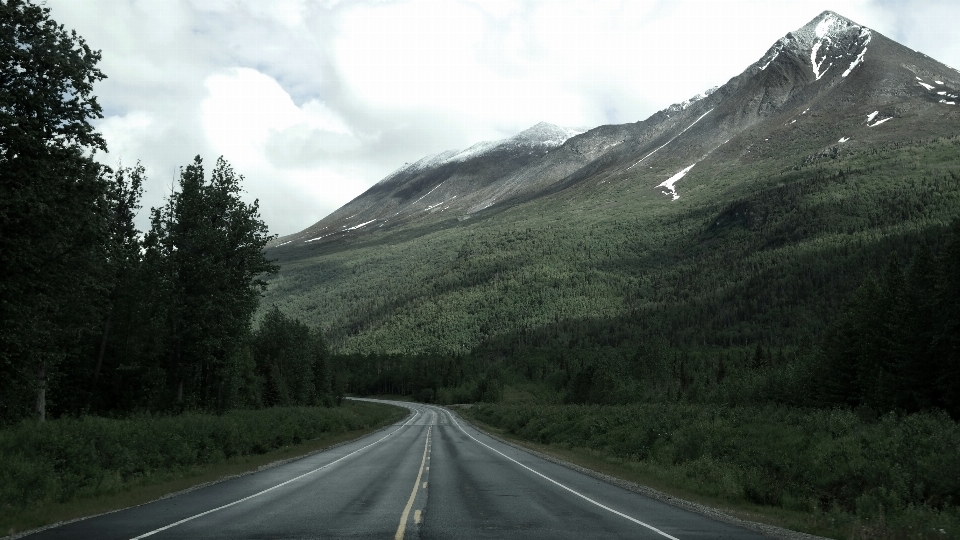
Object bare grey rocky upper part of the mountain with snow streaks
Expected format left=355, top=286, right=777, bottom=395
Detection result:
left=274, top=11, right=960, bottom=251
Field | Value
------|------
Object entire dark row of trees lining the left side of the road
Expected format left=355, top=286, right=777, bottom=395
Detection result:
left=0, top=0, right=337, bottom=425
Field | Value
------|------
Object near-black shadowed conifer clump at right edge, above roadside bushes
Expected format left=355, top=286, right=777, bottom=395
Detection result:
left=818, top=224, right=960, bottom=418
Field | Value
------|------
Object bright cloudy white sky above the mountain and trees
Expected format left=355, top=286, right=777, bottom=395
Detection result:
left=46, top=0, right=960, bottom=235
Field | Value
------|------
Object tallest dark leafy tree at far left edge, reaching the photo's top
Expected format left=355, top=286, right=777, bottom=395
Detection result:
left=0, top=0, right=108, bottom=420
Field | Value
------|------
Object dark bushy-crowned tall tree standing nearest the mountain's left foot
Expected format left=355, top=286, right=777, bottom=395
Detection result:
left=145, top=156, right=277, bottom=408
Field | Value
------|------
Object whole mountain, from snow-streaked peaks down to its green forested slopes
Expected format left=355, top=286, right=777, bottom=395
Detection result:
left=264, top=11, right=960, bottom=356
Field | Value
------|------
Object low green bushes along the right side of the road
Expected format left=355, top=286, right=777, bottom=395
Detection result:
left=464, top=404, right=960, bottom=538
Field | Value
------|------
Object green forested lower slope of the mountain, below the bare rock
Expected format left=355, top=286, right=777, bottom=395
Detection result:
left=265, top=136, right=960, bottom=416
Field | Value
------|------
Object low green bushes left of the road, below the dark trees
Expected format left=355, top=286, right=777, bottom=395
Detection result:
left=0, top=402, right=405, bottom=512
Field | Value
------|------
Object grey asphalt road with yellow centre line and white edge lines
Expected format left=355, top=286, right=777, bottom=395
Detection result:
left=27, top=402, right=766, bottom=540
